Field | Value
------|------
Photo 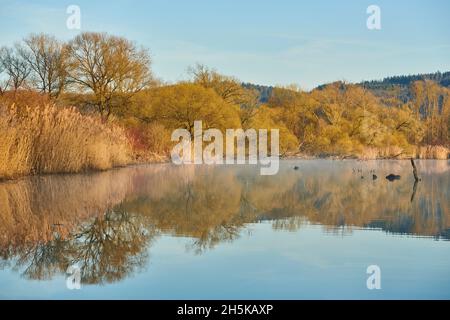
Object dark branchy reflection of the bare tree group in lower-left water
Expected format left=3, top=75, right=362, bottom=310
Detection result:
left=2, top=209, right=155, bottom=284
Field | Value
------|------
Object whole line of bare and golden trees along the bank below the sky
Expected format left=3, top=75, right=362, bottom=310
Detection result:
left=0, top=32, right=450, bottom=158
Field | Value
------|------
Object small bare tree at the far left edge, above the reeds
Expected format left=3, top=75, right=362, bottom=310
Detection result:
left=0, top=45, right=31, bottom=92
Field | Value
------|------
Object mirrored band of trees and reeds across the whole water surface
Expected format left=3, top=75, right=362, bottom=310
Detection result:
left=0, top=162, right=450, bottom=284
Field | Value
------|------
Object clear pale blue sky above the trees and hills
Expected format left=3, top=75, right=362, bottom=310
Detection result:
left=0, top=0, right=450, bottom=89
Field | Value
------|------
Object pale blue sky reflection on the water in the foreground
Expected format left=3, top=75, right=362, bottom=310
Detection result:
left=0, top=223, right=450, bottom=299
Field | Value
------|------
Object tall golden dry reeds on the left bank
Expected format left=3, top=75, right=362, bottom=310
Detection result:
left=0, top=105, right=130, bottom=179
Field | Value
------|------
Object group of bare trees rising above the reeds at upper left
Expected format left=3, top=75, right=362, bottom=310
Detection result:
left=0, top=32, right=152, bottom=120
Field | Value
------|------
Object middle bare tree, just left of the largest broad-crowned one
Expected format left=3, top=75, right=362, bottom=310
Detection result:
left=19, top=34, right=66, bottom=98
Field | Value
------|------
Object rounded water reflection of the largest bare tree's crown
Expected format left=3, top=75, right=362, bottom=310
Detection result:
left=69, top=208, right=155, bottom=283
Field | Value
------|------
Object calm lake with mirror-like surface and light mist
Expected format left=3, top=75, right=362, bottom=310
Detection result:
left=0, top=160, right=450, bottom=299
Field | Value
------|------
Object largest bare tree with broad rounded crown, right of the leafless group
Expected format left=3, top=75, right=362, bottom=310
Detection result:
left=68, top=32, right=152, bottom=120
